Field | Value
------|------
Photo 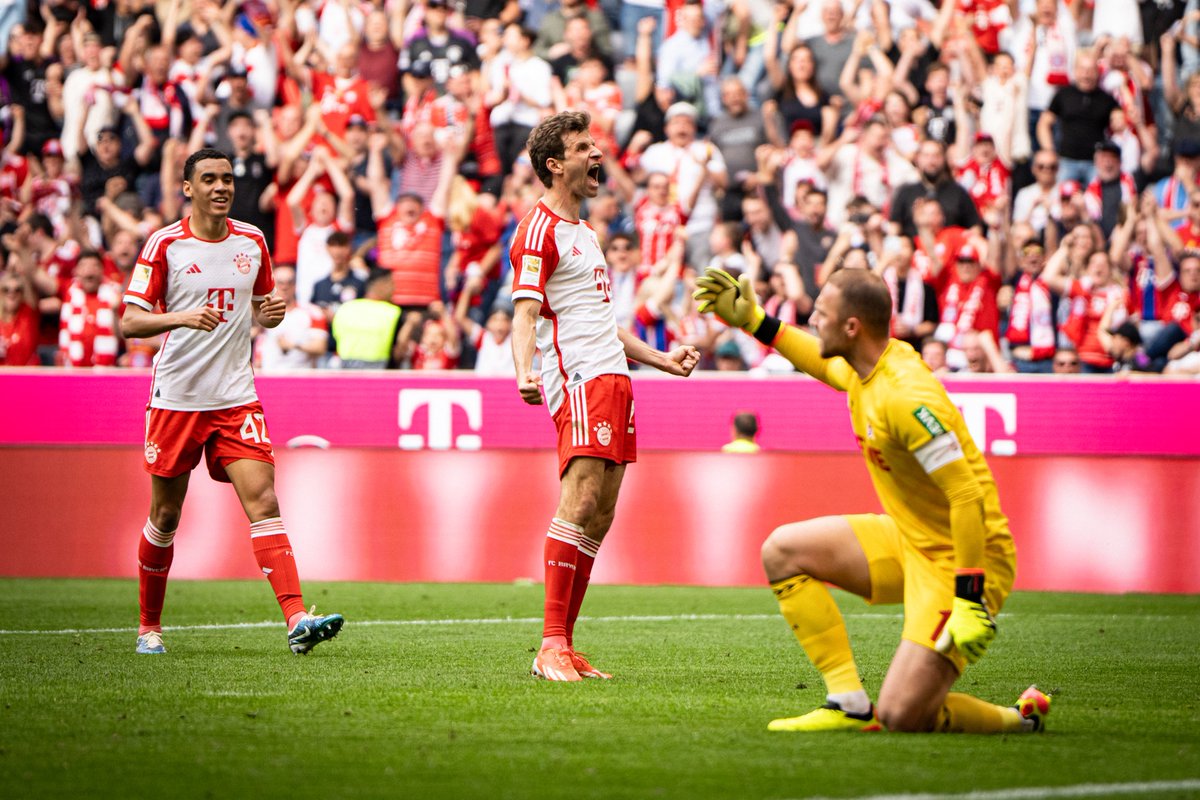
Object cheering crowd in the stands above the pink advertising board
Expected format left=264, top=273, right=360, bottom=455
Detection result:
left=0, top=0, right=1200, bottom=375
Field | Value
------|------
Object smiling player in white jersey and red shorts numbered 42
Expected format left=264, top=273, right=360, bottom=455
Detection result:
left=121, top=149, right=344, bottom=654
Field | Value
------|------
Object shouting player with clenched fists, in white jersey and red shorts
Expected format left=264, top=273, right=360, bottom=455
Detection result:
left=510, top=112, right=700, bottom=681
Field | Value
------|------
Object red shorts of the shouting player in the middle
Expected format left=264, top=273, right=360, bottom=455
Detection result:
left=554, top=375, right=637, bottom=477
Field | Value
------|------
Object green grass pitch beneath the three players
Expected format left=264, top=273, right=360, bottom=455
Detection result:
left=0, top=579, right=1200, bottom=800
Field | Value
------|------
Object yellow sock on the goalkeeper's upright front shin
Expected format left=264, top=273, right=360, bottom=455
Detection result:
left=770, top=575, right=863, bottom=694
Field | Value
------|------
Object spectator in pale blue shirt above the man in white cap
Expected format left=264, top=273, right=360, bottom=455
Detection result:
left=654, top=0, right=721, bottom=119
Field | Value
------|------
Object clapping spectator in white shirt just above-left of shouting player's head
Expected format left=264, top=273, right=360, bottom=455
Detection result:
left=484, top=23, right=554, bottom=175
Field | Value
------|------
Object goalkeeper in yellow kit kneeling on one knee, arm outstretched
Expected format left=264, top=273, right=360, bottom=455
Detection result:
left=696, top=267, right=1050, bottom=733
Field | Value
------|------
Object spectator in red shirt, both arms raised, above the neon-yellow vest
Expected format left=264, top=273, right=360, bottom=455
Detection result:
left=367, top=127, right=461, bottom=311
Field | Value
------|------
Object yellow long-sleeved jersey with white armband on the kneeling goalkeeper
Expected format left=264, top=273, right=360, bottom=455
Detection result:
left=788, top=329, right=1013, bottom=554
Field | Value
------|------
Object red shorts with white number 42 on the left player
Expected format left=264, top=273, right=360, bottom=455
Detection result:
left=145, top=401, right=275, bottom=483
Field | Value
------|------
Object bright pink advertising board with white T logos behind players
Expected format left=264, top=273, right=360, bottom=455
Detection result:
left=0, top=369, right=1200, bottom=457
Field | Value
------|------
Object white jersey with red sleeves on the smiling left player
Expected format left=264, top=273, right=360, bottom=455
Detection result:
left=125, top=217, right=275, bottom=411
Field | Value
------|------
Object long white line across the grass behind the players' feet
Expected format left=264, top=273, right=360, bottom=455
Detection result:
left=0, top=612, right=1171, bottom=636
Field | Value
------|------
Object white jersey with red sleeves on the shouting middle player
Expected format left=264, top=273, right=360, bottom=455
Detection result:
left=509, top=201, right=629, bottom=415
